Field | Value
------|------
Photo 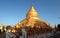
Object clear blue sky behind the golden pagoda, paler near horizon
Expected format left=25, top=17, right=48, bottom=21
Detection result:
left=0, top=0, right=60, bottom=26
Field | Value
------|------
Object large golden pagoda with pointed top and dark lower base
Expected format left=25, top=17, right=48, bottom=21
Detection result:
left=16, top=5, right=52, bottom=35
